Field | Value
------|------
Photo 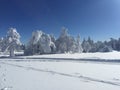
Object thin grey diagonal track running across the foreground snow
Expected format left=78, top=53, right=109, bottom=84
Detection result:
left=0, top=62, right=120, bottom=86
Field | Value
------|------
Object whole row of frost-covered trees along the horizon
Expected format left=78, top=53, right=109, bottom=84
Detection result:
left=0, top=27, right=120, bottom=56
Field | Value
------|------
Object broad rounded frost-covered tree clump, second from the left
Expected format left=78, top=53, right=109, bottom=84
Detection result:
left=25, top=31, right=56, bottom=55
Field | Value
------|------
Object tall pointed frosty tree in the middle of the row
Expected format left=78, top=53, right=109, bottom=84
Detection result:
left=55, top=27, right=81, bottom=53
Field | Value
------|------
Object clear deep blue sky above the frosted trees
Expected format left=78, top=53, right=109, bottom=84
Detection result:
left=0, top=0, right=120, bottom=42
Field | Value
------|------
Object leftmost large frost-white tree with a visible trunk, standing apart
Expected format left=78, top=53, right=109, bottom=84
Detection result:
left=4, top=28, right=21, bottom=57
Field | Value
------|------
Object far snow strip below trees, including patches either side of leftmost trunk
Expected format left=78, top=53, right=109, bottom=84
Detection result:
left=0, top=51, right=120, bottom=60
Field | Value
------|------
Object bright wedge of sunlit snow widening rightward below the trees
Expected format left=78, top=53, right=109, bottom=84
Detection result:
left=20, top=51, right=120, bottom=60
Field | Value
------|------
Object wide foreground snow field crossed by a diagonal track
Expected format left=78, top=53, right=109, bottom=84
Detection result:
left=0, top=60, right=120, bottom=90
